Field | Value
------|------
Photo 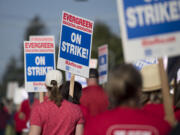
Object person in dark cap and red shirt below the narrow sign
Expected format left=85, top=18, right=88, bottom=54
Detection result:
left=80, top=68, right=109, bottom=116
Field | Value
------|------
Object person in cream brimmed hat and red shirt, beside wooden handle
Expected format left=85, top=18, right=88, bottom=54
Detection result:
left=141, top=64, right=179, bottom=120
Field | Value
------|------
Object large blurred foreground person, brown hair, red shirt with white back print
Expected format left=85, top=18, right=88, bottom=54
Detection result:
left=84, top=64, right=170, bottom=135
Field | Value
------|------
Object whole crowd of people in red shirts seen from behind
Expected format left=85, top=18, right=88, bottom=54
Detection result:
left=0, top=64, right=180, bottom=135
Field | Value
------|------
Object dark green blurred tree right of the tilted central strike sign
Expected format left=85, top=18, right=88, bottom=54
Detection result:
left=91, top=22, right=124, bottom=69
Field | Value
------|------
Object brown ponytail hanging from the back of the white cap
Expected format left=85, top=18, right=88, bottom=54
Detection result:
left=49, top=80, right=63, bottom=107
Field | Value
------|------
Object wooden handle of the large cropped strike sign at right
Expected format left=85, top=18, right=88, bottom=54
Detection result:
left=158, top=58, right=177, bottom=126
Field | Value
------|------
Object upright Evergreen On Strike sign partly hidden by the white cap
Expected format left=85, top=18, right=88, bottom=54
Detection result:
left=24, top=37, right=55, bottom=92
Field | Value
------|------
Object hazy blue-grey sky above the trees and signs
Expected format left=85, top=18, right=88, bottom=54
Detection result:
left=0, top=0, right=120, bottom=80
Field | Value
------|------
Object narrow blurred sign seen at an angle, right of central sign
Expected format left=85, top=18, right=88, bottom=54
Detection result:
left=98, top=45, right=108, bottom=84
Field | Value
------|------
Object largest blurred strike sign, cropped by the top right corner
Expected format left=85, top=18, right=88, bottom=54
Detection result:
left=117, top=0, right=180, bottom=62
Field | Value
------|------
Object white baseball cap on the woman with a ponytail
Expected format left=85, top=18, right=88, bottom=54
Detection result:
left=45, top=70, right=63, bottom=87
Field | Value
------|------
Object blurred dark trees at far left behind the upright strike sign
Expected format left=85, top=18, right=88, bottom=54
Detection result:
left=0, top=16, right=47, bottom=97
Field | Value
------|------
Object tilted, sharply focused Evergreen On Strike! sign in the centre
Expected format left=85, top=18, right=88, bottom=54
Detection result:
left=57, top=11, right=94, bottom=78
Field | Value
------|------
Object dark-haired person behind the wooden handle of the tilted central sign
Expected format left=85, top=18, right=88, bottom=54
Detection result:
left=61, top=81, right=89, bottom=120
